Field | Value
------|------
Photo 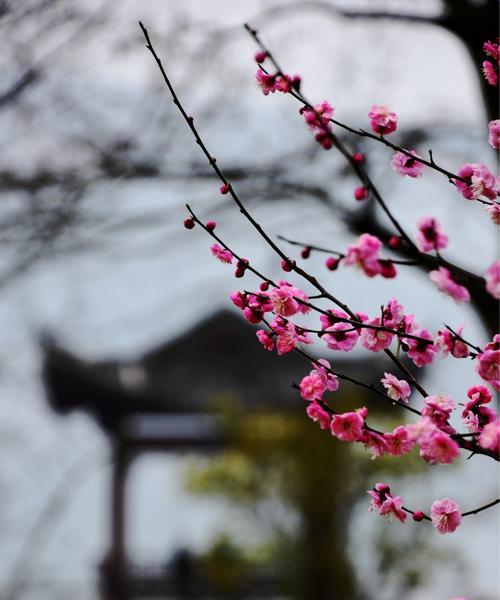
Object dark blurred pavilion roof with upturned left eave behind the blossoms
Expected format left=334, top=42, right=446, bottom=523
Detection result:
left=42, top=310, right=396, bottom=435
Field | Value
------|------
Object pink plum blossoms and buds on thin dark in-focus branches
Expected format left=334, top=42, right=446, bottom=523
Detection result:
left=153, top=21, right=500, bottom=548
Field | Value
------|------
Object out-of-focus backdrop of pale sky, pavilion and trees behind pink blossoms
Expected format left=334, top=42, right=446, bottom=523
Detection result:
left=0, top=0, right=500, bottom=600
